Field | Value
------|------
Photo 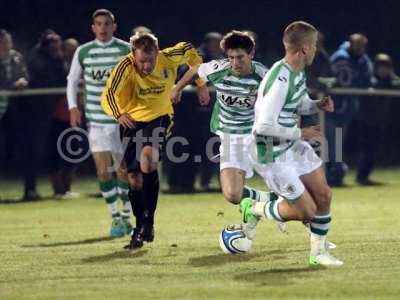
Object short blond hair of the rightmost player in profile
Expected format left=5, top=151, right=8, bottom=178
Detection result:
left=283, top=21, right=318, bottom=52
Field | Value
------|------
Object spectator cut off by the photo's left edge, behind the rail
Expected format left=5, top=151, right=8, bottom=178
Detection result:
left=0, top=29, right=28, bottom=175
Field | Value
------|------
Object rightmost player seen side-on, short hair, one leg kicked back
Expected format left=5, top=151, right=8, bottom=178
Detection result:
left=240, top=22, right=343, bottom=266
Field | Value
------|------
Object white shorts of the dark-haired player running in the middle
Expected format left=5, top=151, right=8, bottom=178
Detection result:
left=219, top=133, right=253, bottom=178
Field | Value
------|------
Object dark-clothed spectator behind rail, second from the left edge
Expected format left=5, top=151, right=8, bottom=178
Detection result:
left=18, top=29, right=67, bottom=201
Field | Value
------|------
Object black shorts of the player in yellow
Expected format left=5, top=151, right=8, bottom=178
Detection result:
left=120, top=115, right=173, bottom=173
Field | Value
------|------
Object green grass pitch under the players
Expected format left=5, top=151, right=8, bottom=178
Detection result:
left=0, top=169, right=400, bottom=300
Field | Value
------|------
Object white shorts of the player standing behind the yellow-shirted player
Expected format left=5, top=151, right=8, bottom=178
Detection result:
left=88, top=125, right=123, bottom=153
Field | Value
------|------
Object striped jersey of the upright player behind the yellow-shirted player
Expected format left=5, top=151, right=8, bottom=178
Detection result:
left=67, top=37, right=130, bottom=126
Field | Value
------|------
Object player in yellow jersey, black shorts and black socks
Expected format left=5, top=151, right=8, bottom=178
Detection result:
left=101, top=32, right=209, bottom=249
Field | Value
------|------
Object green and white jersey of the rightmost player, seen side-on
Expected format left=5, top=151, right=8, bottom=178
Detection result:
left=253, top=60, right=317, bottom=163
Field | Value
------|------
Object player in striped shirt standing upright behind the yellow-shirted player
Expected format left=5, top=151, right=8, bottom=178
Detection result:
left=67, top=9, right=132, bottom=237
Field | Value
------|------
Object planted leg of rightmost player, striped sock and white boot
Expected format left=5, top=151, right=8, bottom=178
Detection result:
left=300, top=167, right=343, bottom=266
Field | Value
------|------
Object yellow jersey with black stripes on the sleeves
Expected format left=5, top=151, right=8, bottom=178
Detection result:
left=101, top=42, right=204, bottom=122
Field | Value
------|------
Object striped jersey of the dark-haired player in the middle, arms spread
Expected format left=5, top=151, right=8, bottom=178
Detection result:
left=198, top=59, right=267, bottom=134
